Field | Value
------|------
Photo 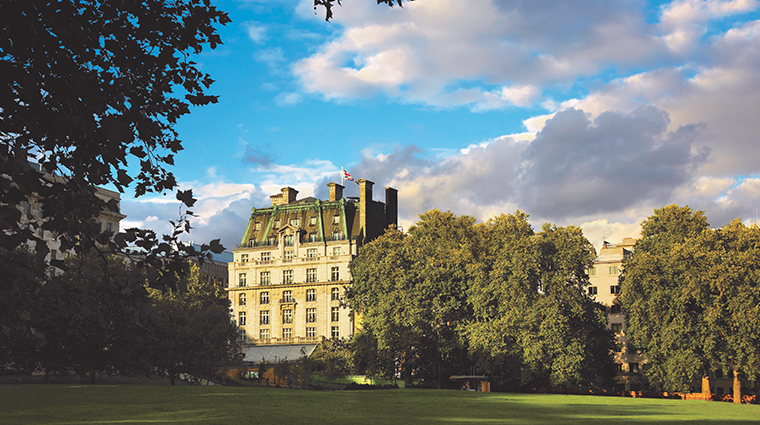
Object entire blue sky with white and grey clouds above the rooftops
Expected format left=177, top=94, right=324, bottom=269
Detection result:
left=122, top=0, right=760, bottom=249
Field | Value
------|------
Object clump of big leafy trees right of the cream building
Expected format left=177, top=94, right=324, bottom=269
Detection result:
left=347, top=210, right=615, bottom=390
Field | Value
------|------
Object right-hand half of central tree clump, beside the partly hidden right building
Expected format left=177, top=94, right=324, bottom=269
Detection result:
left=464, top=211, right=614, bottom=389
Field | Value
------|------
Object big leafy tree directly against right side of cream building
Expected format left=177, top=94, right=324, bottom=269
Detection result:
left=348, top=210, right=474, bottom=386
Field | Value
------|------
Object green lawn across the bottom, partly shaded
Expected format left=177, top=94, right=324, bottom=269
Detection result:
left=0, top=385, right=760, bottom=425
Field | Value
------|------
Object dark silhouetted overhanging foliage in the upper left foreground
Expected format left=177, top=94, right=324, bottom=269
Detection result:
left=0, top=0, right=230, bottom=274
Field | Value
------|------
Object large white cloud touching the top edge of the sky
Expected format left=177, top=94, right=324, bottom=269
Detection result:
left=294, top=0, right=669, bottom=111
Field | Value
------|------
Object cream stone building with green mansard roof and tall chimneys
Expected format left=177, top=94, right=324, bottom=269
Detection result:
left=226, top=179, right=398, bottom=348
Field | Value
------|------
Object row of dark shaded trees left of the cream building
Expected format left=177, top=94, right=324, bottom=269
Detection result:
left=0, top=249, right=238, bottom=384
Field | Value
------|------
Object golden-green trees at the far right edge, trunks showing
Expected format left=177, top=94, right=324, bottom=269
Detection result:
left=620, top=205, right=760, bottom=403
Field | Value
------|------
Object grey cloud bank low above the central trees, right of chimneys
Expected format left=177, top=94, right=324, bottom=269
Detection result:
left=350, top=107, right=712, bottom=230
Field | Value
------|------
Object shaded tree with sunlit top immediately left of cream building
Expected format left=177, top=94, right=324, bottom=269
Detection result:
left=151, top=265, right=238, bottom=385
